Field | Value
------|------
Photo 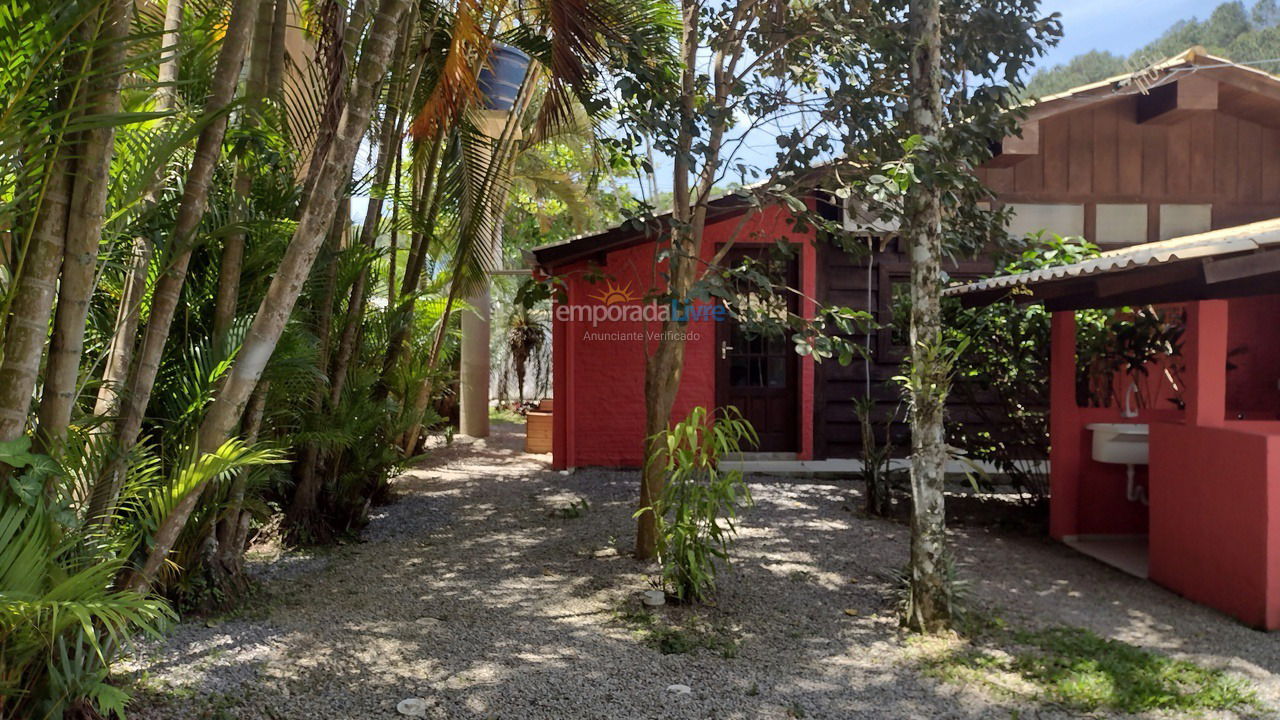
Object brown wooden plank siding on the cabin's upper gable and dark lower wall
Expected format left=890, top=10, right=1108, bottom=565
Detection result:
left=814, top=96, right=1280, bottom=459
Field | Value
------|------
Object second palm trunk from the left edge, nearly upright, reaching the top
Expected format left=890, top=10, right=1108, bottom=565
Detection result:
left=36, top=0, right=133, bottom=451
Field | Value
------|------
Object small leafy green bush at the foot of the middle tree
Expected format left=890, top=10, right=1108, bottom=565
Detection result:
left=636, top=406, right=759, bottom=601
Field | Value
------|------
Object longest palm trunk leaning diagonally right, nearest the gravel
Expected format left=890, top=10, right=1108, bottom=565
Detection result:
left=128, top=0, right=408, bottom=591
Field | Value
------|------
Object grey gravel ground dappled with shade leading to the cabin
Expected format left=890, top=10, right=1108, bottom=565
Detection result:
left=131, top=425, right=1280, bottom=720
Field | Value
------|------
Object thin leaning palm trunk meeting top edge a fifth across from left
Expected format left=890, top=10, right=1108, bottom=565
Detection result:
left=88, top=3, right=259, bottom=527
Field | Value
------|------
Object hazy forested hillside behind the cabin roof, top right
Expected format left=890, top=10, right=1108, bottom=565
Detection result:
left=1027, top=0, right=1280, bottom=97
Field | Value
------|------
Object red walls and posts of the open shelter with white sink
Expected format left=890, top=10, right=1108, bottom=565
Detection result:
left=1050, top=296, right=1280, bottom=629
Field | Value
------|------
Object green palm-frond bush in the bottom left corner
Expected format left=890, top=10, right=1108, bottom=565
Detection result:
left=0, top=437, right=279, bottom=717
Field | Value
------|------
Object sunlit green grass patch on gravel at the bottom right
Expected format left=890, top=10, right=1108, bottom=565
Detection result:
left=925, top=626, right=1263, bottom=714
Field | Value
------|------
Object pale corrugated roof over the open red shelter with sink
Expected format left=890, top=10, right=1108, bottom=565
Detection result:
left=942, top=218, right=1280, bottom=296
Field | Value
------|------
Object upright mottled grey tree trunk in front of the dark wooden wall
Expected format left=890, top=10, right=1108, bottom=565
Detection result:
left=906, top=0, right=951, bottom=633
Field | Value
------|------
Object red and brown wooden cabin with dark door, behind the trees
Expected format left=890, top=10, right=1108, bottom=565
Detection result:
left=532, top=50, right=1280, bottom=479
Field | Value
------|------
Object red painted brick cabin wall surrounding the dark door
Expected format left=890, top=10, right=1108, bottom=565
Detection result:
left=552, top=208, right=817, bottom=468
